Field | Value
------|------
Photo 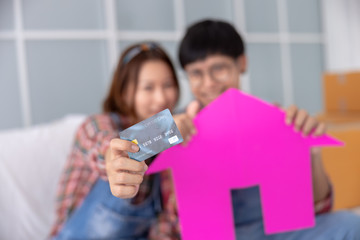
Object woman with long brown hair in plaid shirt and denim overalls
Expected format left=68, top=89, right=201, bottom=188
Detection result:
left=51, top=43, right=194, bottom=239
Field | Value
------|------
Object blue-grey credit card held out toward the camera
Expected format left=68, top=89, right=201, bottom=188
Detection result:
left=120, top=109, right=183, bottom=161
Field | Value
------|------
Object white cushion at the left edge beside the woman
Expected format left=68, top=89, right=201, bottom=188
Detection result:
left=0, top=115, right=85, bottom=240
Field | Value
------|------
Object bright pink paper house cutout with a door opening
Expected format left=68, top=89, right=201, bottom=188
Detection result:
left=147, top=89, right=341, bottom=240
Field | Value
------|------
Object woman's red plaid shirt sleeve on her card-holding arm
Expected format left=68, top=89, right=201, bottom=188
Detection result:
left=50, top=114, right=152, bottom=236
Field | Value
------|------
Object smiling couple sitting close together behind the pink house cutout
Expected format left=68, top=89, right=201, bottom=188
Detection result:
left=51, top=20, right=360, bottom=240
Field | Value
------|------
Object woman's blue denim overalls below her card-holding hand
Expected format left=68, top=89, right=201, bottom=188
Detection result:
left=53, top=175, right=161, bottom=240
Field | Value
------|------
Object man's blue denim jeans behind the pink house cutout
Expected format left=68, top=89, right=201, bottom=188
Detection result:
left=232, top=187, right=360, bottom=240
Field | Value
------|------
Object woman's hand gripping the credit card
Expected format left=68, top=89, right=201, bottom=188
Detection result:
left=105, top=138, right=148, bottom=198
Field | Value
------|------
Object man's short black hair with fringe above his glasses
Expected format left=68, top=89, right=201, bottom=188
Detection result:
left=179, top=19, right=245, bottom=68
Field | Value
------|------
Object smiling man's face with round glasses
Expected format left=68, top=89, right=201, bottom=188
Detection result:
left=185, top=55, right=246, bottom=106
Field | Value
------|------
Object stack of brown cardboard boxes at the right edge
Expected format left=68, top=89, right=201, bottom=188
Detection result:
left=317, top=72, right=360, bottom=210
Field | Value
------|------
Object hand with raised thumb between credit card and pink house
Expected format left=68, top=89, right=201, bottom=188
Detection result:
left=174, top=101, right=200, bottom=146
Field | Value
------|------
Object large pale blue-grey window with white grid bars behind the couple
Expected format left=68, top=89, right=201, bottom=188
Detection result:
left=0, top=0, right=323, bottom=129
